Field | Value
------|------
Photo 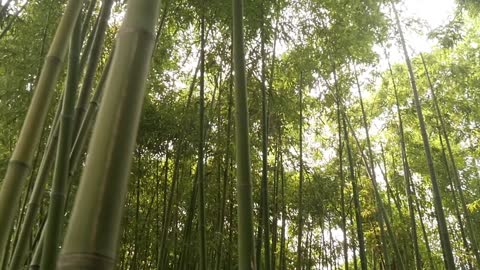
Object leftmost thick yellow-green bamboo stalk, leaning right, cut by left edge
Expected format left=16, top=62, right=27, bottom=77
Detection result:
left=0, top=0, right=83, bottom=258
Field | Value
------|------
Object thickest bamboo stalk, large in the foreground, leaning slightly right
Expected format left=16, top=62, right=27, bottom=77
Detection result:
left=57, top=0, right=160, bottom=270
